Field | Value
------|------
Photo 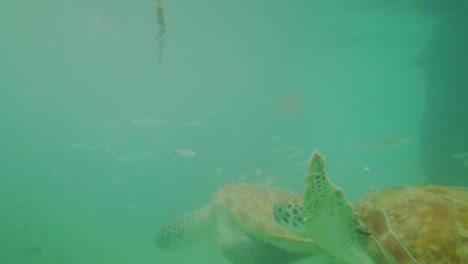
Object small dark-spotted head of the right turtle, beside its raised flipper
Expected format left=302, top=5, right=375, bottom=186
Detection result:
left=273, top=203, right=309, bottom=237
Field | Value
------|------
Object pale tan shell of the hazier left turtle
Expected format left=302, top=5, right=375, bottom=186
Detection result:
left=213, top=183, right=319, bottom=254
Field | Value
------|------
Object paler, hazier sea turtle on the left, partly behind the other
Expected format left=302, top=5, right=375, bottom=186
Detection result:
left=156, top=182, right=325, bottom=264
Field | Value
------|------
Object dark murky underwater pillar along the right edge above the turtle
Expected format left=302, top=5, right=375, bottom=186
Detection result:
left=420, top=4, right=468, bottom=186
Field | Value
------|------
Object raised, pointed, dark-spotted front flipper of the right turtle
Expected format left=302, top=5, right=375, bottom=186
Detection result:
left=303, top=151, right=374, bottom=264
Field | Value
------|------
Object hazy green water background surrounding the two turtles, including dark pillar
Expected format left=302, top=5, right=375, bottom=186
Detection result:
left=0, top=0, right=468, bottom=264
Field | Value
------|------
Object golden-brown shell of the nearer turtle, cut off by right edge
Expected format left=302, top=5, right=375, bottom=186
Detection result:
left=354, top=186, right=468, bottom=263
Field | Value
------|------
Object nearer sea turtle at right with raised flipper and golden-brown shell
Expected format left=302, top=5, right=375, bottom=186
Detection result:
left=273, top=151, right=468, bottom=264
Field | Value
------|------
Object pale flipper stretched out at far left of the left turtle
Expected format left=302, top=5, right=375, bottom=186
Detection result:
left=155, top=205, right=212, bottom=249
